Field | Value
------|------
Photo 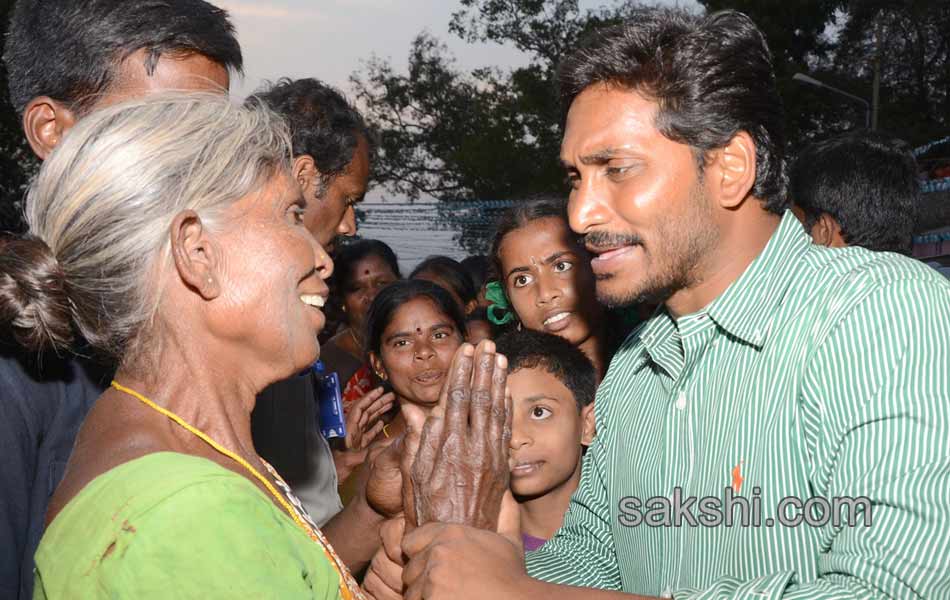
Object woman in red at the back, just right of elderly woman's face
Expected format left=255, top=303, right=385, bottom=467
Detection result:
left=322, top=240, right=400, bottom=413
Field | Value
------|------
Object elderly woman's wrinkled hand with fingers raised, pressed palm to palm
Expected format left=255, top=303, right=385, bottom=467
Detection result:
left=402, top=340, right=511, bottom=531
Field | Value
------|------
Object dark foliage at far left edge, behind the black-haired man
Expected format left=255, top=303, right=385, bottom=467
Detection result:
left=0, top=0, right=37, bottom=232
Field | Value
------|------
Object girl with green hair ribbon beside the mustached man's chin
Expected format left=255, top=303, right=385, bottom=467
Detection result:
left=488, top=200, right=613, bottom=380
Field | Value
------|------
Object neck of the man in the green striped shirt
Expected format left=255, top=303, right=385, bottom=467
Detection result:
left=665, top=207, right=782, bottom=318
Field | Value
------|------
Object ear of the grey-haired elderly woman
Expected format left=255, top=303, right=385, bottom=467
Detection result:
left=170, top=210, right=221, bottom=300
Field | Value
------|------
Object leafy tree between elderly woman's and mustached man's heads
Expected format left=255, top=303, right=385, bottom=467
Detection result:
left=351, top=0, right=640, bottom=252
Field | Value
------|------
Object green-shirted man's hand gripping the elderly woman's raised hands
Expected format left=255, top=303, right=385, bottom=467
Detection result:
left=398, top=492, right=524, bottom=600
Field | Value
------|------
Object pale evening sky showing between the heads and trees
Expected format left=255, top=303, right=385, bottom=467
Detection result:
left=218, top=0, right=697, bottom=273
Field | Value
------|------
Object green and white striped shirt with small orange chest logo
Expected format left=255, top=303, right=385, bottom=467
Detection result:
left=527, top=213, right=950, bottom=599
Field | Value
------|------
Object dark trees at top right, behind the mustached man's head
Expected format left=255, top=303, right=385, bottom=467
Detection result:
left=700, top=0, right=950, bottom=150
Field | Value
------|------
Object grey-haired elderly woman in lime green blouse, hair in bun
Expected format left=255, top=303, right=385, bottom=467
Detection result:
left=0, top=95, right=360, bottom=598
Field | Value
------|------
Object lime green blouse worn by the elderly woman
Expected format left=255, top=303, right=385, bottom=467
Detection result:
left=34, top=452, right=340, bottom=599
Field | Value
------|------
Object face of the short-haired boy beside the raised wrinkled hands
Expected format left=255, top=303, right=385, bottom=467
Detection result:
left=508, top=367, right=594, bottom=497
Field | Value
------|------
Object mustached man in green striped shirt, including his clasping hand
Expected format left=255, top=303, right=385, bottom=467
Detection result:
left=386, top=5, right=950, bottom=600
